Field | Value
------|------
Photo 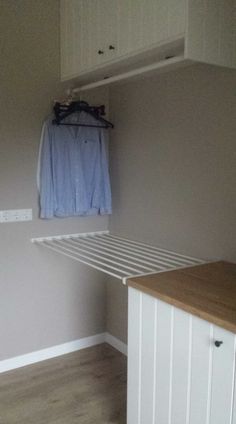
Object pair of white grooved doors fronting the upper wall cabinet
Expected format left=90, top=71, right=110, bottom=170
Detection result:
left=61, top=0, right=185, bottom=79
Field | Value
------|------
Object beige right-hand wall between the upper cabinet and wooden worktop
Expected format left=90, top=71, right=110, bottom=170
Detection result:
left=107, top=65, right=236, bottom=340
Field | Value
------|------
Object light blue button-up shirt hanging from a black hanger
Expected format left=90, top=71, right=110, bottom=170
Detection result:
left=39, top=112, right=112, bottom=218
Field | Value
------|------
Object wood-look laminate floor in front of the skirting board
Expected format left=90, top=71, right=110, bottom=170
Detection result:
left=0, top=344, right=126, bottom=424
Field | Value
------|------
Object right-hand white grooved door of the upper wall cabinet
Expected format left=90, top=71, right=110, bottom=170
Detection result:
left=117, top=0, right=186, bottom=56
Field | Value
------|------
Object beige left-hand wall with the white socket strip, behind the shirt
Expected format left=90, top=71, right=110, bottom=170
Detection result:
left=0, top=0, right=108, bottom=360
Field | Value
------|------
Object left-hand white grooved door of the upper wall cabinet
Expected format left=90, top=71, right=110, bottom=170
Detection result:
left=60, top=0, right=118, bottom=79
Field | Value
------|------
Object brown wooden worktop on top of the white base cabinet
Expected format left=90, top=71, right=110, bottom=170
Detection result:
left=127, top=261, right=236, bottom=333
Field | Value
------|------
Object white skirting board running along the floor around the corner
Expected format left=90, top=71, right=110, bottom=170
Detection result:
left=0, top=333, right=127, bottom=373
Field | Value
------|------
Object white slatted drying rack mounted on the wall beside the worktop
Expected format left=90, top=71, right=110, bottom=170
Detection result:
left=31, top=231, right=203, bottom=284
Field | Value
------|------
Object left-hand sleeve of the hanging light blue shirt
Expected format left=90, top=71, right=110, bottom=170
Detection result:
left=39, top=123, right=54, bottom=218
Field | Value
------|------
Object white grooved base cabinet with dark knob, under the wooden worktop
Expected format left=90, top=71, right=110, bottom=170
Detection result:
left=127, top=287, right=236, bottom=424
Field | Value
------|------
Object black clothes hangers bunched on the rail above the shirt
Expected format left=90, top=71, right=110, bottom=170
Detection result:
left=52, top=101, right=114, bottom=128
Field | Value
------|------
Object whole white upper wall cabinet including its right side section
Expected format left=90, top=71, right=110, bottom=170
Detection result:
left=60, top=0, right=236, bottom=82
